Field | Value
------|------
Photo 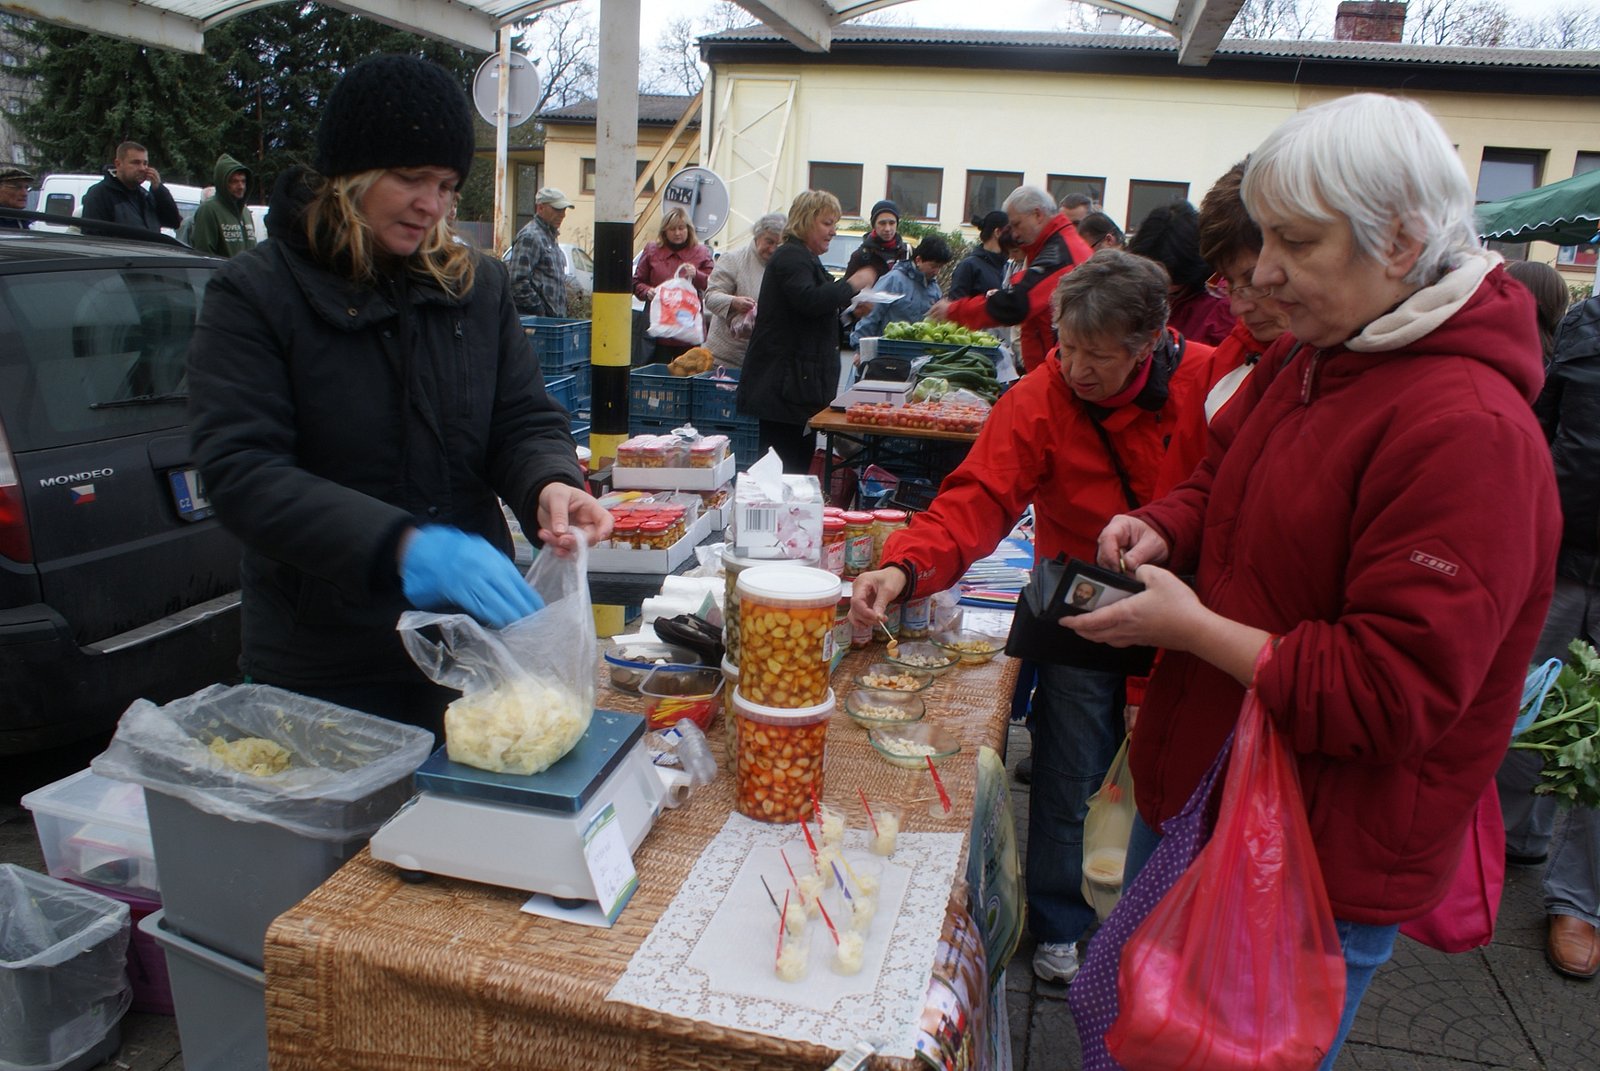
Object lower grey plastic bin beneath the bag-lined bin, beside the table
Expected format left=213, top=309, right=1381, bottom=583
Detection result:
left=139, top=911, right=267, bottom=1071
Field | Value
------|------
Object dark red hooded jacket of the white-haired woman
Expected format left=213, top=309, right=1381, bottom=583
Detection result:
left=1131, top=259, right=1560, bottom=925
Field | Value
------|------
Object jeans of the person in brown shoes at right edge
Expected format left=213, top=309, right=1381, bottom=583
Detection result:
left=1494, top=578, right=1600, bottom=925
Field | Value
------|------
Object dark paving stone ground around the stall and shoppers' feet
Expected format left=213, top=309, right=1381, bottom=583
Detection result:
left=0, top=725, right=1600, bottom=1071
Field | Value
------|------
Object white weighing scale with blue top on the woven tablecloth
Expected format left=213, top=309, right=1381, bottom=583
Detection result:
left=371, top=711, right=664, bottom=908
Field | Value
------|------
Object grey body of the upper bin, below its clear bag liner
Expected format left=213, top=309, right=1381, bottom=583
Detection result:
left=144, top=776, right=413, bottom=967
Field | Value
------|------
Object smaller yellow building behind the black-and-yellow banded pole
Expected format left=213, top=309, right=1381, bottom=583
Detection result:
left=530, top=93, right=699, bottom=251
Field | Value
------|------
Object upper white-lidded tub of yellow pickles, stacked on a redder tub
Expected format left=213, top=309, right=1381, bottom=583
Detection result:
left=734, top=565, right=838, bottom=708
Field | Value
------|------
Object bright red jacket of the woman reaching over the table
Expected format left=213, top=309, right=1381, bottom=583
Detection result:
left=883, top=331, right=1210, bottom=599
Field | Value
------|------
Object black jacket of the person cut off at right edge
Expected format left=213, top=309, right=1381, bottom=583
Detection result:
left=1533, top=296, right=1600, bottom=586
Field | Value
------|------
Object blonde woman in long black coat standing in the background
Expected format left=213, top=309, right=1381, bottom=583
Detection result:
left=739, top=189, right=878, bottom=472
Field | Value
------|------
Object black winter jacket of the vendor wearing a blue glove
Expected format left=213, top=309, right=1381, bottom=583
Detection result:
left=189, top=167, right=582, bottom=690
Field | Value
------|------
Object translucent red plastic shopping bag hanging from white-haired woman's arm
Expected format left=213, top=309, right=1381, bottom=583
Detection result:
left=1106, top=666, right=1344, bottom=1071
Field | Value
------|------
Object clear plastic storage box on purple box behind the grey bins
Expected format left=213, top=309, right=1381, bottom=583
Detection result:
left=22, top=770, right=162, bottom=900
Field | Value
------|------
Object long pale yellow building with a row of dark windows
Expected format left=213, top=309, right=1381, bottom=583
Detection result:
left=701, top=24, right=1600, bottom=283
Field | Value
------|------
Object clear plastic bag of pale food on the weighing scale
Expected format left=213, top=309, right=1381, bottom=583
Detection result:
left=398, top=535, right=598, bottom=775
